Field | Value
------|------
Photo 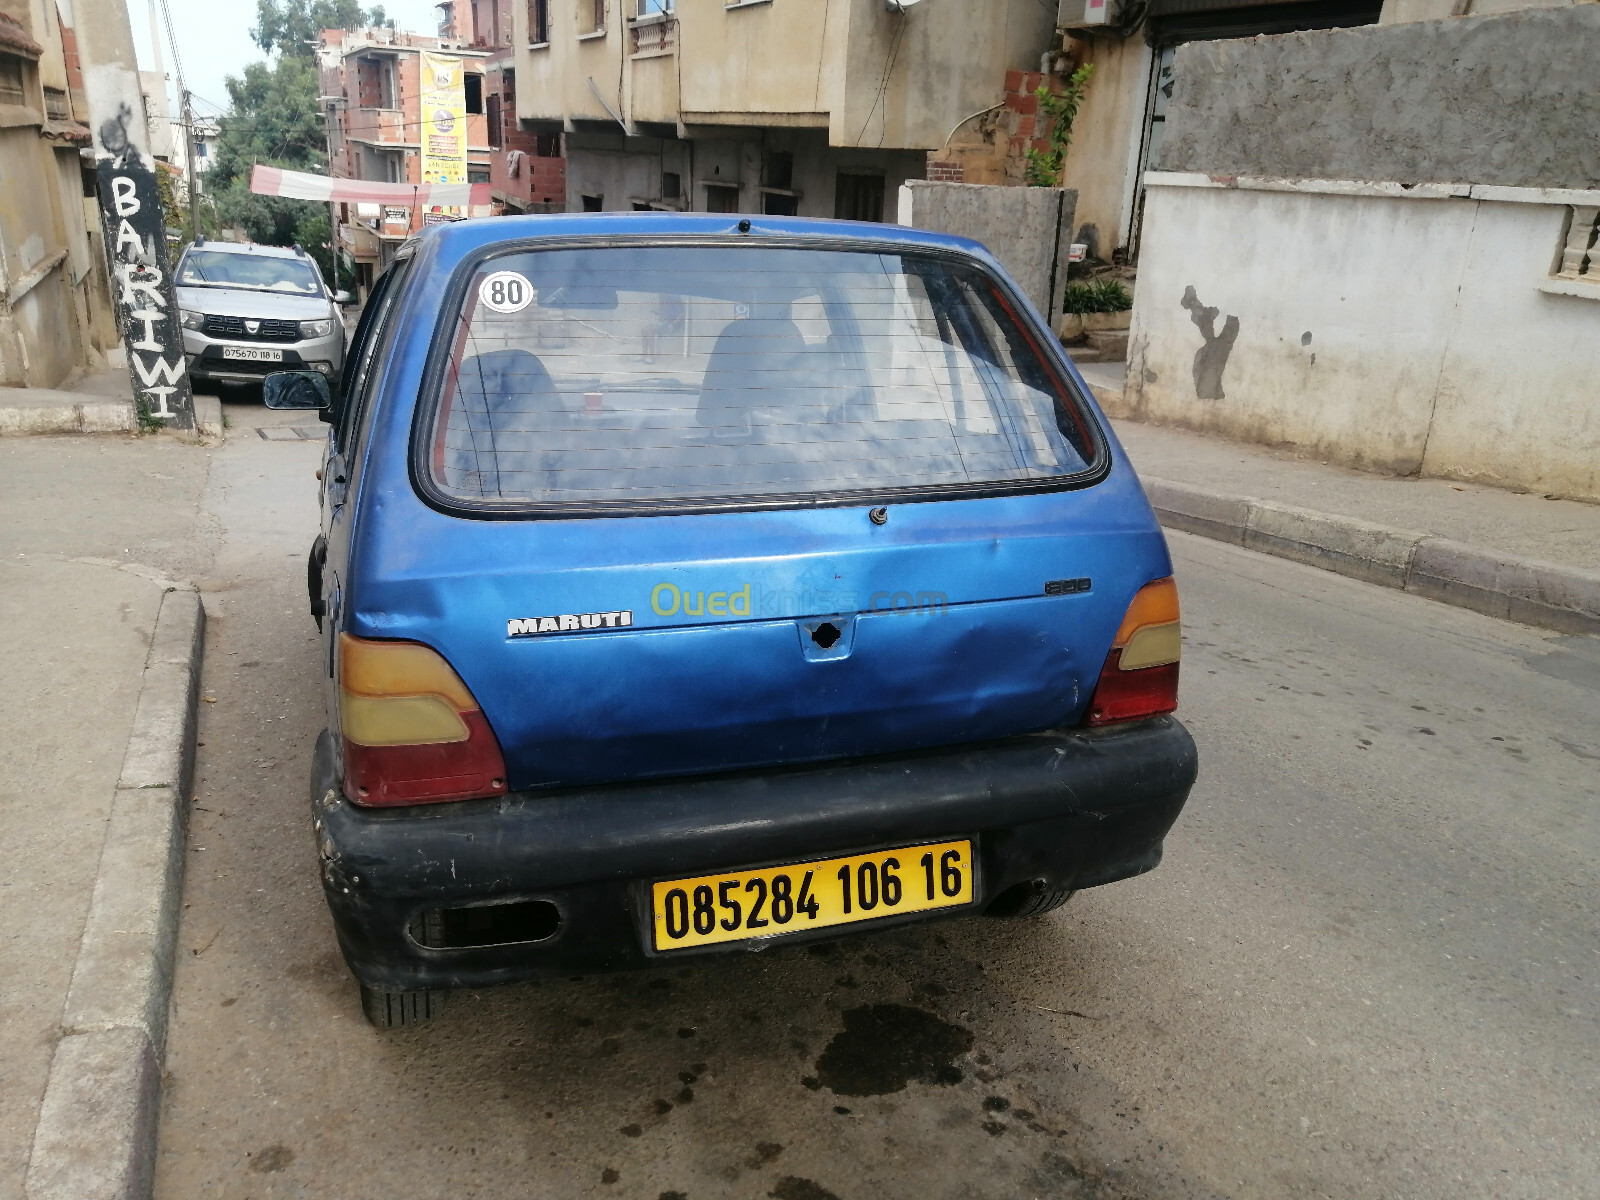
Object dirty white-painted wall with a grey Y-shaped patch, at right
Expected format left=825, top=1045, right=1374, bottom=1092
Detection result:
left=1122, top=174, right=1600, bottom=499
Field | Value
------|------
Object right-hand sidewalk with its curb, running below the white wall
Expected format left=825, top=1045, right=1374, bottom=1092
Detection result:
left=1078, top=363, right=1600, bottom=634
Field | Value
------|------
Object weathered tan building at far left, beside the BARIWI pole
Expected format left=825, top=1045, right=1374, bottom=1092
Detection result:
left=0, top=0, right=117, bottom=387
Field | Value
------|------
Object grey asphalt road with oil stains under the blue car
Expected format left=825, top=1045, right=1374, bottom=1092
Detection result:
left=157, top=405, right=1600, bottom=1200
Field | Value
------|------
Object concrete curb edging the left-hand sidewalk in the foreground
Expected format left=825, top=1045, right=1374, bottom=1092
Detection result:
left=27, top=590, right=205, bottom=1200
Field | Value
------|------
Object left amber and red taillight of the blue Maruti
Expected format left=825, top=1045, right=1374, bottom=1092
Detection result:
left=339, top=634, right=506, bottom=806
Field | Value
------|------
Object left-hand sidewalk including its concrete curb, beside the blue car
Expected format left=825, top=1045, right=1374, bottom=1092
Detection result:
left=0, top=428, right=211, bottom=1200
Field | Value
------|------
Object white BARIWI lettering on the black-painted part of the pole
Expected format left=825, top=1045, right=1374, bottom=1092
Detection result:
left=98, top=106, right=195, bottom=429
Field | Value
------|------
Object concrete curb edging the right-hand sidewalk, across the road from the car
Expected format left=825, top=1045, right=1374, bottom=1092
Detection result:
left=1144, top=478, right=1600, bottom=634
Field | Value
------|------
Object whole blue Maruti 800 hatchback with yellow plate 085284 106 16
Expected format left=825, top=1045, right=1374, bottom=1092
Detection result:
left=267, top=214, right=1195, bottom=1026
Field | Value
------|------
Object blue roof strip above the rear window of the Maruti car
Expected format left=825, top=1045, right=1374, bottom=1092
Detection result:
left=414, top=213, right=994, bottom=272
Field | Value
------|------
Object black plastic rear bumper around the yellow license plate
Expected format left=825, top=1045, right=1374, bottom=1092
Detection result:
left=310, top=717, right=1197, bottom=990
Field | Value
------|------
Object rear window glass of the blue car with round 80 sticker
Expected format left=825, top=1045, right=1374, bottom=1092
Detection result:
left=429, top=246, right=1094, bottom=509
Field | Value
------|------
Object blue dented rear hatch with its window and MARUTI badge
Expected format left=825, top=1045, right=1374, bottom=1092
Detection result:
left=357, top=240, right=1165, bottom=787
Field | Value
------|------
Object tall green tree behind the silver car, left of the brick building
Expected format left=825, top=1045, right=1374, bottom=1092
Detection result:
left=206, top=0, right=394, bottom=275
